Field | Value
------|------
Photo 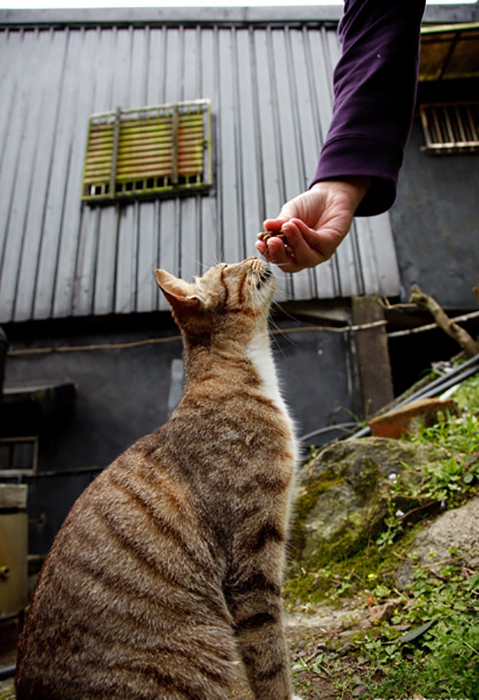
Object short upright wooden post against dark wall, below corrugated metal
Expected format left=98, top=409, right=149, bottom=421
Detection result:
left=352, top=297, right=394, bottom=418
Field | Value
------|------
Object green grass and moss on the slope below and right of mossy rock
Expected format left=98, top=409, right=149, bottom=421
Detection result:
left=286, top=376, right=479, bottom=700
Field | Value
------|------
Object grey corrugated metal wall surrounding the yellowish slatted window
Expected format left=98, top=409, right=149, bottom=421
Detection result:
left=0, top=8, right=399, bottom=322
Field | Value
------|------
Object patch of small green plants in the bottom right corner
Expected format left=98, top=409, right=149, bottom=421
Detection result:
left=360, top=565, right=479, bottom=700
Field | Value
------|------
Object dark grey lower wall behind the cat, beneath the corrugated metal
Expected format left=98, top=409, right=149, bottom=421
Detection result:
left=5, top=314, right=359, bottom=553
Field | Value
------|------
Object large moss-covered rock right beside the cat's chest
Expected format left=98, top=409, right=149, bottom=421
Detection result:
left=291, top=438, right=448, bottom=571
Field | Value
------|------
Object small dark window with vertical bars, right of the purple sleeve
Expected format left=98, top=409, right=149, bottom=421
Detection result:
left=420, top=102, right=479, bottom=153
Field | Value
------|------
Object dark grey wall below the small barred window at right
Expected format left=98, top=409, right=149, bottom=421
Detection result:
left=391, top=120, right=479, bottom=309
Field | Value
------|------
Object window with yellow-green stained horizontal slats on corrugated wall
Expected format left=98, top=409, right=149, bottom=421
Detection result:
left=82, top=100, right=212, bottom=202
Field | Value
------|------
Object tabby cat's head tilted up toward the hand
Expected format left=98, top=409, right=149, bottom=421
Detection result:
left=155, top=258, right=275, bottom=342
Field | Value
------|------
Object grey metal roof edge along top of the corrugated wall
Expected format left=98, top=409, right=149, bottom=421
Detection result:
left=0, top=5, right=342, bottom=26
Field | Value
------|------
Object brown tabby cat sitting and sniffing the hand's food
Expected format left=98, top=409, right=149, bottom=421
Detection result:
left=16, top=258, right=304, bottom=700
